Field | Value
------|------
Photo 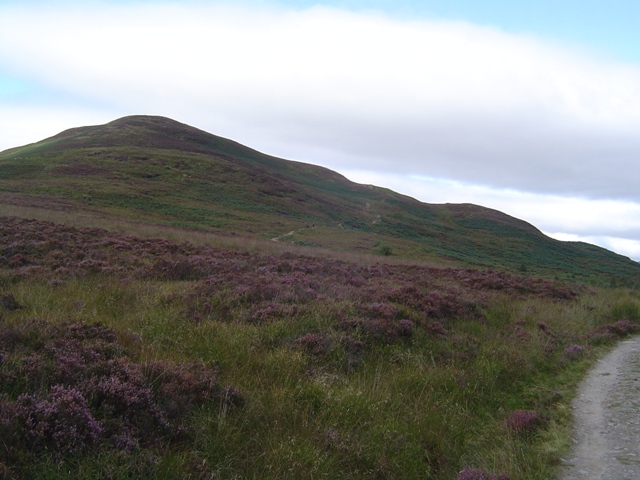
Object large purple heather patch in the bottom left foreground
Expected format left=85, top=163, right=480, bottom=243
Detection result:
left=0, top=320, right=244, bottom=464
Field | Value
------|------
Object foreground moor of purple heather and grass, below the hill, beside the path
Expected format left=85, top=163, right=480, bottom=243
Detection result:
left=0, top=218, right=640, bottom=479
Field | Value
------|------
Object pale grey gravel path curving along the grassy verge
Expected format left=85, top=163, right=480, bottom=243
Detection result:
left=560, top=337, right=640, bottom=480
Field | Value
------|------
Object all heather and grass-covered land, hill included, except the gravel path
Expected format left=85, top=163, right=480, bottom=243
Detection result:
left=0, top=116, right=640, bottom=480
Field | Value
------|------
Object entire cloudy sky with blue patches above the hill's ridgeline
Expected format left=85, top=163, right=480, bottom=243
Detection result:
left=0, top=0, right=640, bottom=261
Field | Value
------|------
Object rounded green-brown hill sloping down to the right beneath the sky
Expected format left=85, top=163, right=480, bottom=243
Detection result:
left=0, top=116, right=640, bottom=285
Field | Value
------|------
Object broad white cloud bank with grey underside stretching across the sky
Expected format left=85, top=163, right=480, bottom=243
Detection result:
left=0, top=3, right=640, bottom=200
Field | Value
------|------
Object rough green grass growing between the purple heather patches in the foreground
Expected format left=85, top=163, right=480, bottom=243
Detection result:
left=0, top=218, right=640, bottom=479
